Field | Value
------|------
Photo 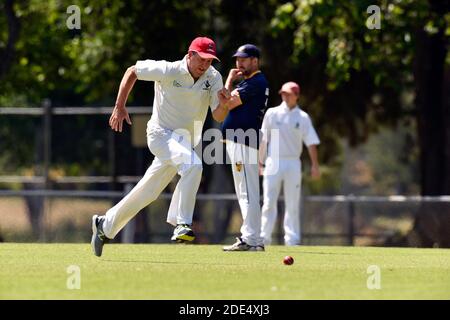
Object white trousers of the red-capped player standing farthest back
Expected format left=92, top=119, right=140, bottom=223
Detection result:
left=261, top=157, right=302, bottom=246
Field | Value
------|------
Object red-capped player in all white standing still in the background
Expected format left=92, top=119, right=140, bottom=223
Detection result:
left=260, top=82, right=320, bottom=245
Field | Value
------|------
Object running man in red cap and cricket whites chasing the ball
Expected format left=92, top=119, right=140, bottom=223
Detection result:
left=91, top=37, right=230, bottom=256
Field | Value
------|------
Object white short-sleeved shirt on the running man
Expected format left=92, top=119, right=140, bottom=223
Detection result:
left=135, top=56, right=223, bottom=146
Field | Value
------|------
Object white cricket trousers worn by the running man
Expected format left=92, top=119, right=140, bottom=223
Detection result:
left=103, top=125, right=202, bottom=239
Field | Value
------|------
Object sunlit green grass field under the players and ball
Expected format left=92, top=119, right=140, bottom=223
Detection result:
left=0, top=243, right=450, bottom=300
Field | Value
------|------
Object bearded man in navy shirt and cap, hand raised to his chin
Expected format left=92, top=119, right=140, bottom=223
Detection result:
left=222, top=44, right=269, bottom=251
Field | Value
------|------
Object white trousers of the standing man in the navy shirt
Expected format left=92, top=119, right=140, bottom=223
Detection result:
left=226, top=140, right=263, bottom=246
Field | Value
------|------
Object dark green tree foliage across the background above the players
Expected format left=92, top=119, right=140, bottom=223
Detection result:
left=0, top=0, right=450, bottom=190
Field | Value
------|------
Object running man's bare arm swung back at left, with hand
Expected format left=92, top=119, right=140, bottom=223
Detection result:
left=109, top=66, right=137, bottom=132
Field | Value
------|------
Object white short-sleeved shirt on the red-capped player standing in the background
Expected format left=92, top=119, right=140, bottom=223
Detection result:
left=261, top=102, right=320, bottom=159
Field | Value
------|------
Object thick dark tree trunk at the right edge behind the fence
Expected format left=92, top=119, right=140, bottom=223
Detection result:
left=408, top=1, right=450, bottom=247
